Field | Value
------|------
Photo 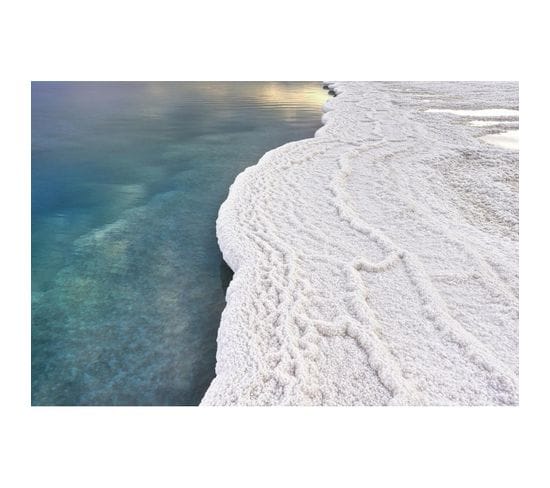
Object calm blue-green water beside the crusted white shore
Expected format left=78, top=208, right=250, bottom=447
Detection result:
left=32, top=82, right=327, bottom=405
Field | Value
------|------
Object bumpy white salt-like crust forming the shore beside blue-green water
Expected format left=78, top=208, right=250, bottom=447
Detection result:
left=202, top=82, right=518, bottom=405
